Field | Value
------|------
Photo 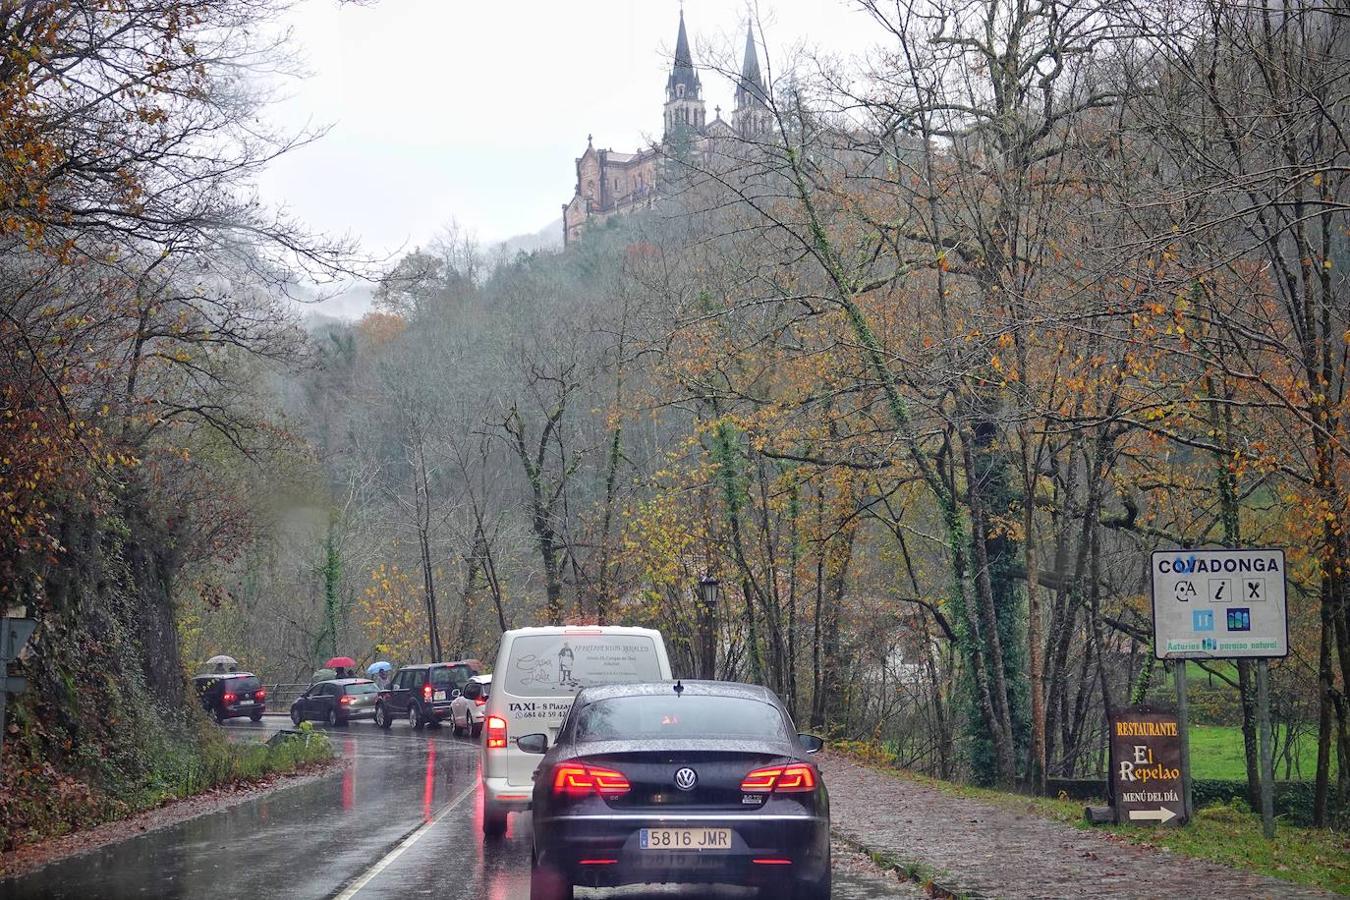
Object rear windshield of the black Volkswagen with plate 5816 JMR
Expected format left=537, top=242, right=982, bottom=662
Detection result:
left=576, top=692, right=791, bottom=741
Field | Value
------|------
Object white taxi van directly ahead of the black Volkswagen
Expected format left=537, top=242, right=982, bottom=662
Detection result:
left=482, top=625, right=671, bottom=837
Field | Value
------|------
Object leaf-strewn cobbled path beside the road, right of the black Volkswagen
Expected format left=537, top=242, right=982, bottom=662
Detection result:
left=821, top=753, right=1332, bottom=897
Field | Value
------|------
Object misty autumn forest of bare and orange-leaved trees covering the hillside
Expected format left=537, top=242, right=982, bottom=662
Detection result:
left=0, top=0, right=1350, bottom=823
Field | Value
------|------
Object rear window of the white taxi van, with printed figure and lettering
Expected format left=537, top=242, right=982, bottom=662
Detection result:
left=493, top=634, right=666, bottom=696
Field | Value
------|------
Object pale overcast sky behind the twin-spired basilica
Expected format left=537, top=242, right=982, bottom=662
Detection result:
left=261, top=0, right=876, bottom=264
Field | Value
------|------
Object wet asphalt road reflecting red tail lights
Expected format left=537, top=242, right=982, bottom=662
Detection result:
left=0, top=716, right=899, bottom=900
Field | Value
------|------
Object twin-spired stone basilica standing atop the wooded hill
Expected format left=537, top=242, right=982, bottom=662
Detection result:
left=563, top=11, right=772, bottom=244
